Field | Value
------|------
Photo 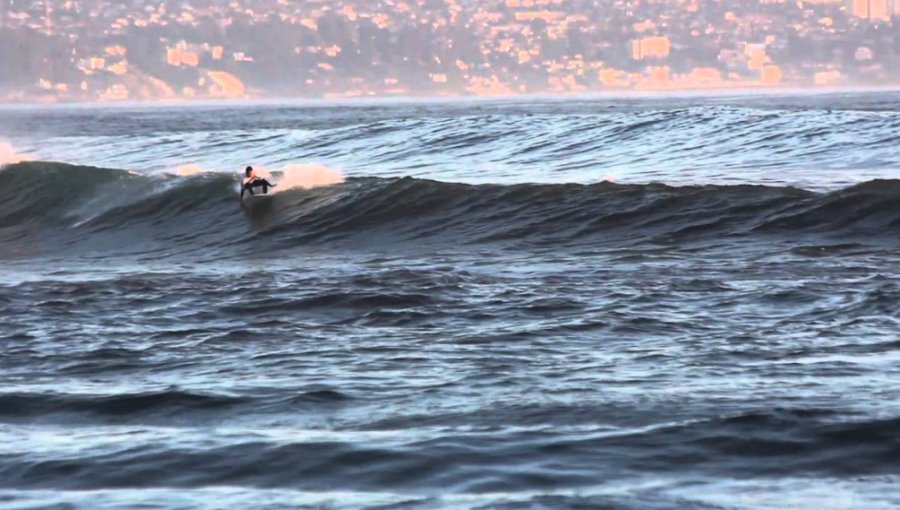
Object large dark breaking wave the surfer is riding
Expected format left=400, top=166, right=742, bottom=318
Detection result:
left=0, top=162, right=900, bottom=256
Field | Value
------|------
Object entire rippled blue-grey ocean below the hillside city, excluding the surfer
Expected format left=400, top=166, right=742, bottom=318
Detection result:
left=0, top=92, right=900, bottom=509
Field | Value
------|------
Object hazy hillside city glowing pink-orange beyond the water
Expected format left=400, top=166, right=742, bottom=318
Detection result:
left=0, top=0, right=900, bottom=102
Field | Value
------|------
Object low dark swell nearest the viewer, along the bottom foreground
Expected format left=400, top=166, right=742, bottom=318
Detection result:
left=0, top=409, right=900, bottom=493
